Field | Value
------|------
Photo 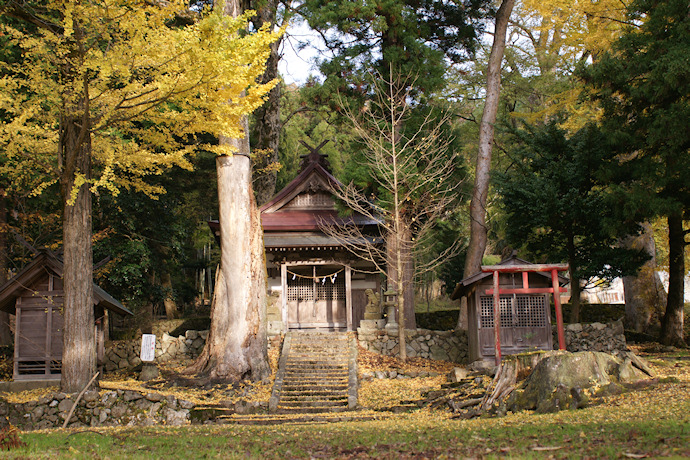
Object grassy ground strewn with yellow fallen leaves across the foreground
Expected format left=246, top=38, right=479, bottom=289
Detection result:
left=0, top=347, right=690, bottom=459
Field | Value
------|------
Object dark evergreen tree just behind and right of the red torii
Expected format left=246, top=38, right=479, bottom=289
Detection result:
left=496, top=121, right=647, bottom=323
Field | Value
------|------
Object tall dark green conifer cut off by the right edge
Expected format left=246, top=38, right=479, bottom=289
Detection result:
left=584, top=0, right=690, bottom=346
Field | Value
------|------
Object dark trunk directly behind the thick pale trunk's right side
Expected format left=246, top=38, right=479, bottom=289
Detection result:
left=251, top=0, right=282, bottom=206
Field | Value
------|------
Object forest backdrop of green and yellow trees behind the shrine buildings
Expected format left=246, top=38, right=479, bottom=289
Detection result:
left=0, top=0, right=690, bottom=356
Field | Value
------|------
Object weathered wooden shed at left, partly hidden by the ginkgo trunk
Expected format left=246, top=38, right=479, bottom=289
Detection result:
left=0, top=250, right=132, bottom=380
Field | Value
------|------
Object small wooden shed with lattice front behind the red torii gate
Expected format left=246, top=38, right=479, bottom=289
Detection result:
left=451, top=257, right=568, bottom=361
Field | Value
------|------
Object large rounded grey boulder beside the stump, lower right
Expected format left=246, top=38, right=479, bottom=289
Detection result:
left=506, top=351, right=652, bottom=413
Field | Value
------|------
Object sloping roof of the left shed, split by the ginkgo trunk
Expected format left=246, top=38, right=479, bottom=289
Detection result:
left=0, top=250, right=132, bottom=315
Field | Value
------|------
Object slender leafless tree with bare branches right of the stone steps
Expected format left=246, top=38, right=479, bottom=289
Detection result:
left=321, top=72, right=460, bottom=360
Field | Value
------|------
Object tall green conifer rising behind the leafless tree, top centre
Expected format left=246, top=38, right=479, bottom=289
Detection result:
left=300, top=0, right=490, bottom=328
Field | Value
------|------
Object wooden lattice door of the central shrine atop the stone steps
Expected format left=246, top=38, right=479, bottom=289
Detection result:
left=286, top=265, right=347, bottom=329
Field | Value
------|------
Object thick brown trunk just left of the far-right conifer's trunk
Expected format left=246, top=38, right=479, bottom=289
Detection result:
left=623, top=222, right=666, bottom=332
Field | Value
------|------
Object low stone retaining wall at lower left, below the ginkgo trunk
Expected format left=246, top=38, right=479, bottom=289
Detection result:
left=0, top=390, right=194, bottom=430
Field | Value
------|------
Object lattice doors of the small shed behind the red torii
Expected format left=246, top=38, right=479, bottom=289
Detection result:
left=478, top=294, right=552, bottom=356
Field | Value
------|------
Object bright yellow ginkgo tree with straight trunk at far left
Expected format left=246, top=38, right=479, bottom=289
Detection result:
left=0, top=0, right=278, bottom=392
